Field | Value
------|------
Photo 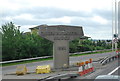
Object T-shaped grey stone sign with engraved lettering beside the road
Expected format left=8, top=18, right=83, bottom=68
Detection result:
left=39, top=25, right=84, bottom=69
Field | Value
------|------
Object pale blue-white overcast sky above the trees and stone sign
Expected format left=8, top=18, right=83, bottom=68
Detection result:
left=0, top=0, right=120, bottom=39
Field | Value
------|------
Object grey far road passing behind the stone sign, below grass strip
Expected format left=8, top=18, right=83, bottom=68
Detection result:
left=2, top=52, right=114, bottom=74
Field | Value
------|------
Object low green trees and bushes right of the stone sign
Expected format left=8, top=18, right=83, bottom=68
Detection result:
left=70, top=39, right=111, bottom=53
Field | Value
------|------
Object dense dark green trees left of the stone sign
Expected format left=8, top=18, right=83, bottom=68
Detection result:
left=1, top=22, right=52, bottom=61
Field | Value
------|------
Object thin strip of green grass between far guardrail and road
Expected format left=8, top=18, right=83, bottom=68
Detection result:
left=0, top=51, right=111, bottom=67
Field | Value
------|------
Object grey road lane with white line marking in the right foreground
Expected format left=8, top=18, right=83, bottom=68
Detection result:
left=61, top=59, right=120, bottom=81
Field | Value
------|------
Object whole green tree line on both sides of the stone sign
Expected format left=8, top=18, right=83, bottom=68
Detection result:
left=0, top=22, right=111, bottom=61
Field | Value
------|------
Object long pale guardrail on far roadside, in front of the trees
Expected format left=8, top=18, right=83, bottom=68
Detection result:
left=0, top=49, right=111, bottom=64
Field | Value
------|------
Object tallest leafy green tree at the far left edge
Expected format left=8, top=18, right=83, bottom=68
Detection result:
left=1, top=22, right=22, bottom=60
